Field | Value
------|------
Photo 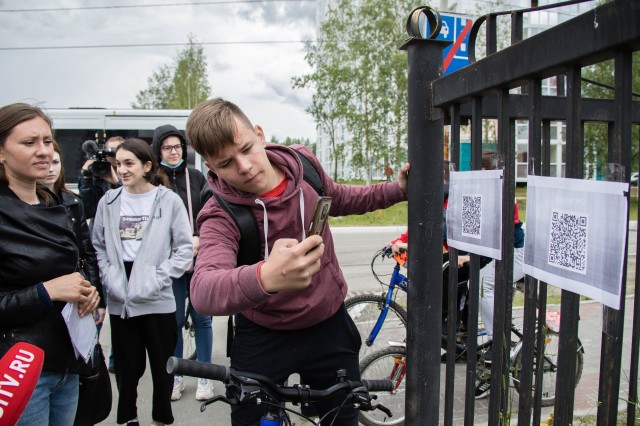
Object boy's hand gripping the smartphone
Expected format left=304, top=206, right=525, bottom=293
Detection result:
left=260, top=235, right=324, bottom=293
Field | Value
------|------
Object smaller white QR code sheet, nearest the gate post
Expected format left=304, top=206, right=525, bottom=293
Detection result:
left=447, top=170, right=503, bottom=260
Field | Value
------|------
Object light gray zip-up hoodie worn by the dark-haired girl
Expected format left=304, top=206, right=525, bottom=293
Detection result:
left=92, top=185, right=193, bottom=318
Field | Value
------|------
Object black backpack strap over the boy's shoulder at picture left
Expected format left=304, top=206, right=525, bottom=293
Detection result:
left=213, top=192, right=261, bottom=266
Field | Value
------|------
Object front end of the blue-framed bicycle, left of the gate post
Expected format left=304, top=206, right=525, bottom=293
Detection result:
left=344, top=246, right=408, bottom=358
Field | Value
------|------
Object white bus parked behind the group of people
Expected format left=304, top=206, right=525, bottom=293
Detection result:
left=45, top=108, right=202, bottom=189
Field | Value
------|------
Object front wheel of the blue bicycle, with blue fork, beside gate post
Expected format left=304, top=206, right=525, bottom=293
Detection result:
left=344, top=294, right=407, bottom=359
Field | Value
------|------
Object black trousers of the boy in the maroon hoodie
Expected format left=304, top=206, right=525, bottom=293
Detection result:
left=231, top=305, right=362, bottom=426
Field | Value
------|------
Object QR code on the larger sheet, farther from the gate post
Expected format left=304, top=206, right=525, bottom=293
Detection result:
left=549, top=210, right=587, bottom=274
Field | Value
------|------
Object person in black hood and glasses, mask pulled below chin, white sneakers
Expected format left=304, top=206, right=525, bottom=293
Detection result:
left=152, top=124, right=213, bottom=401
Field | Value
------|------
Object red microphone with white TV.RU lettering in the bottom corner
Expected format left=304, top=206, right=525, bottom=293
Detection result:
left=0, top=342, right=44, bottom=425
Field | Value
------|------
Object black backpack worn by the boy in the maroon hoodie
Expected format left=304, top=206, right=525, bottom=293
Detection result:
left=201, top=149, right=324, bottom=356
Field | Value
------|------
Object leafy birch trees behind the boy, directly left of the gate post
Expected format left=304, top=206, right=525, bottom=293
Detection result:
left=292, top=0, right=416, bottom=182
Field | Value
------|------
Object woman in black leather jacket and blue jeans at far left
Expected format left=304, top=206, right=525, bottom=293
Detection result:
left=0, top=103, right=100, bottom=426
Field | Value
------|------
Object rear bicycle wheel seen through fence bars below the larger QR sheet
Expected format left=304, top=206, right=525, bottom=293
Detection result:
left=513, top=331, right=584, bottom=407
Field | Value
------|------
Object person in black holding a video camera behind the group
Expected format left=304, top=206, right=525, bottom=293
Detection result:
left=78, top=136, right=124, bottom=220
